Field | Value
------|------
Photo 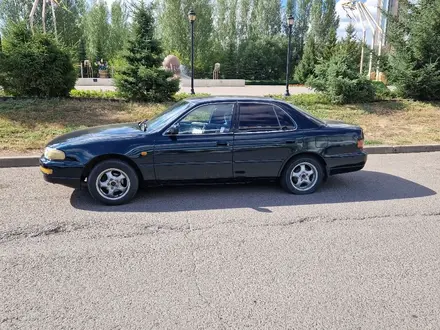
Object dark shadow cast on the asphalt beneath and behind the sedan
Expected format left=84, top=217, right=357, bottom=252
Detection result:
left=70, top=171, right=436, bottom=212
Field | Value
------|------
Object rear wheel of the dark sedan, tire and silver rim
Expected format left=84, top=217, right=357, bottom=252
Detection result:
left=280, top=156, right=324, bottom=195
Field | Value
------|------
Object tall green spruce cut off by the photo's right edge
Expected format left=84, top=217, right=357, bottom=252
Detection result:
left=388, top=0, right=440, bottom=100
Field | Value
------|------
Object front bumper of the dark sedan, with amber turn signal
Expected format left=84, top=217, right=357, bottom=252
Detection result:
left=40, top=157, right=83, bottom=189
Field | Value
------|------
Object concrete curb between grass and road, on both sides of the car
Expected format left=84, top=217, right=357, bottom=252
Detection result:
left=0, top=144, right=440, bottom=168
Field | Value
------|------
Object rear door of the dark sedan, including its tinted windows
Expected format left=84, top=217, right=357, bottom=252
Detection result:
left=233, top=102, right=301, bottom=178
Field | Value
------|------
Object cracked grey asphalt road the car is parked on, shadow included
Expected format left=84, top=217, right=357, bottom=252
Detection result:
left=0, top=153, right=440, bottom=330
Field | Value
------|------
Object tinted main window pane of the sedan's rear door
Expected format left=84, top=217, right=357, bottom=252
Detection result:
left=238, top=104, right=281, bottom=132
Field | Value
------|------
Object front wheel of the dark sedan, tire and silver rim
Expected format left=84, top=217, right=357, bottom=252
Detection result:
left=87, top=159, right=139, bottom=205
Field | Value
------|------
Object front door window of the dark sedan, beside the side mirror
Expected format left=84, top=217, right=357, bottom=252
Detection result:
left=179, top=103, right=234, bottom=135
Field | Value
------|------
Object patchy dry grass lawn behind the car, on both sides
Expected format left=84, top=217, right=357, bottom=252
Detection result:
left=0, top=99, right=440, bottom=155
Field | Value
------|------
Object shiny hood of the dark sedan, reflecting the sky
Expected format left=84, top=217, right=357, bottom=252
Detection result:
left=47, top=123, right=145, bottom=147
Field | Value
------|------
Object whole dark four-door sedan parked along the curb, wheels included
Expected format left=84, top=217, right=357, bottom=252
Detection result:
left=40, top=97, right=367, bottom=205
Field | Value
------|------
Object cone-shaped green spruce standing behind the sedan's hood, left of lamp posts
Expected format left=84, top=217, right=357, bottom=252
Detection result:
left=116, top=1, right=179, bottom=102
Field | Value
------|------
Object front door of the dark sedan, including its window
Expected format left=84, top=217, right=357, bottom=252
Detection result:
left=154, top=103, right=235, bottom=181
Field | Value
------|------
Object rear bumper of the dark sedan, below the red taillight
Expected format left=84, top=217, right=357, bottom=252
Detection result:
left=325, top=151, right=368, bottom=175
